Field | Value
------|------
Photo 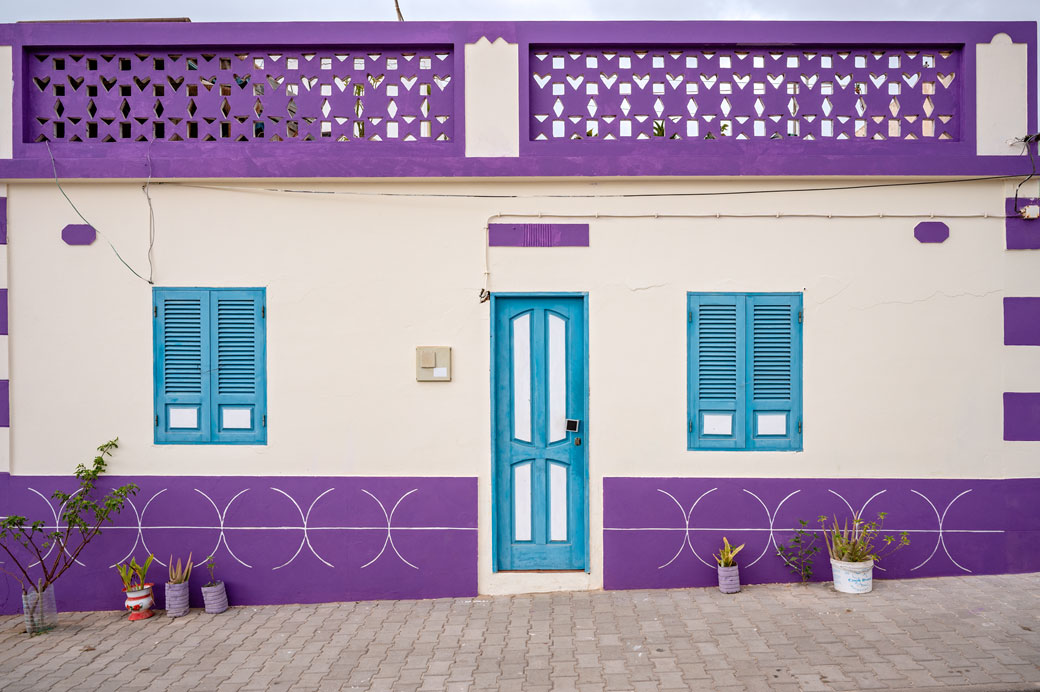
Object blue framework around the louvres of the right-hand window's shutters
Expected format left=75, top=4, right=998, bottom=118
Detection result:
left=686, top=291, right=805, bottom=452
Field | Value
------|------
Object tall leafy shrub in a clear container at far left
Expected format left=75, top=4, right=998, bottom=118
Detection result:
left=0, top=438, right=137, bottom=635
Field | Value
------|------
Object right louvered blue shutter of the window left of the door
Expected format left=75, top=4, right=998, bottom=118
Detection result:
left=209, top=288, right=267, bottom=444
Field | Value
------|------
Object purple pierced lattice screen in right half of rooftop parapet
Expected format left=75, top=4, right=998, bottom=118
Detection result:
left=530, top=48, right=961, bottom=140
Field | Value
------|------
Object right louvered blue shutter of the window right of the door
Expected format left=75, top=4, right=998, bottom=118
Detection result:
left=747, top=293, right=802, bottom=450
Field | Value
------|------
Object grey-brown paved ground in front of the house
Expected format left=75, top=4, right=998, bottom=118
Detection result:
left=0, top=574, right=1040, bottom=692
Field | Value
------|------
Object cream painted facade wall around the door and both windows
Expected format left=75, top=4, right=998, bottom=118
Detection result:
left=9, top=175, right=1040, bottom=592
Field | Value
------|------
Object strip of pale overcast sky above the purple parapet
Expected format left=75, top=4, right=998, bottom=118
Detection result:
left=0, top=0, right=1040, bottom=22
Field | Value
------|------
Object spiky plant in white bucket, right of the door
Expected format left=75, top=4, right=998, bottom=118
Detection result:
left=820, top=512, right=910, bottom=593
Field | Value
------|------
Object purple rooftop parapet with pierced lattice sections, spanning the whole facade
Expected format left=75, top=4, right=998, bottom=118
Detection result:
left=0, top=22, right=1037, bottom=180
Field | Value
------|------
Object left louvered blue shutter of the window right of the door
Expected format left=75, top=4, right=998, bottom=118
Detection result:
left=687, top=293, right=747, bottom=450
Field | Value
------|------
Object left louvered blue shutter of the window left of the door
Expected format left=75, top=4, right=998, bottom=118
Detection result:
left=152, top=288, right=210, bottom=443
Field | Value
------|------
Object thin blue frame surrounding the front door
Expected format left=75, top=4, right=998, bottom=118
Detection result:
left=488, top=291, right=592, bottom=574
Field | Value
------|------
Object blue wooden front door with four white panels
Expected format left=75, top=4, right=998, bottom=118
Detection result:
left=492, top=296, right=588, bottom=569
